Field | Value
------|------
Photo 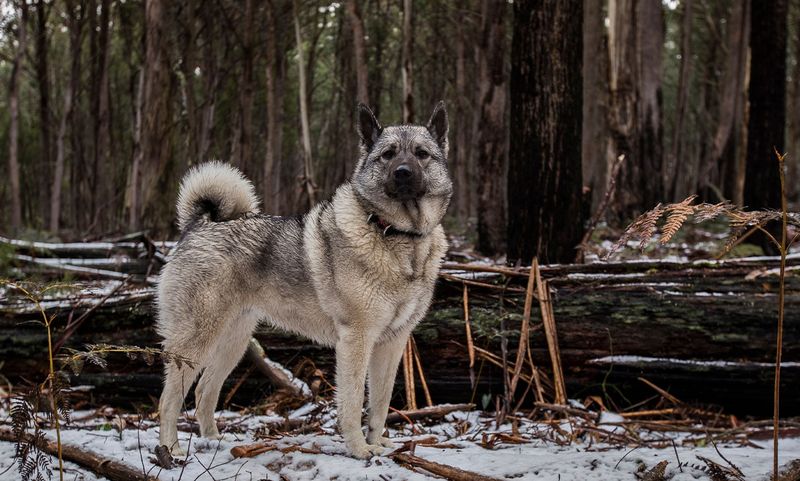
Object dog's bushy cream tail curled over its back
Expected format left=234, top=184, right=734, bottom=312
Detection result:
left=178, top=161, right=258, bottom=232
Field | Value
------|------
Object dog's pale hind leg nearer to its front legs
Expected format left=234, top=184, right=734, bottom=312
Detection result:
left=194, top=322, right=255, bottom=439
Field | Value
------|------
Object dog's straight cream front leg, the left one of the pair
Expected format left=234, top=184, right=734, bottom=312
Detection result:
left=336, top=327, right=383, bottom=459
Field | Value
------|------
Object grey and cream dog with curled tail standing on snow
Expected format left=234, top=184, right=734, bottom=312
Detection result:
left=158, top=102, right=452, bottom=458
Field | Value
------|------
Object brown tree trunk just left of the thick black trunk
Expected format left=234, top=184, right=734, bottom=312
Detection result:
left=473, top=0, right=506, bottom=256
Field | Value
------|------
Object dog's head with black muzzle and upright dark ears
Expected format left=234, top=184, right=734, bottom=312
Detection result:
left=353, top=102, right=453, bottom=234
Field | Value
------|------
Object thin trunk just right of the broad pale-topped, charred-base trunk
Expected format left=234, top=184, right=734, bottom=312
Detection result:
left=670, top=0, right=700, bottom=200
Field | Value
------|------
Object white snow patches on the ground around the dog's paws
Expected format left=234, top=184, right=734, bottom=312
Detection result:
left=0, top=406, right=800, bottom=481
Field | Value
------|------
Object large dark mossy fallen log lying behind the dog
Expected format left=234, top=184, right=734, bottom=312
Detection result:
left=0, top=256, right=800, bottom=415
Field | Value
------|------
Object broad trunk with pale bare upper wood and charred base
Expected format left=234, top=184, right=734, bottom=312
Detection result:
left=608, top=0, right=667, bottom=222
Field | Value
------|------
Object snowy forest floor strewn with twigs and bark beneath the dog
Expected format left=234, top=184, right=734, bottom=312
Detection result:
left=0, top=402, right=800, bottom=481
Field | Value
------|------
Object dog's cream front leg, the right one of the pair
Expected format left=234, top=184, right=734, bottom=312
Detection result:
left=367, top=334, right=408, bottom=448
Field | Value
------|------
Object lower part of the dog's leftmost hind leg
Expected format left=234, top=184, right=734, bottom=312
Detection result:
left=158, top=362, right=199, bottom=455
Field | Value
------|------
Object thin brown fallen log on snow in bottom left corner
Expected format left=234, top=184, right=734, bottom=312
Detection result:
left=0, top=429, right=159, bottom=481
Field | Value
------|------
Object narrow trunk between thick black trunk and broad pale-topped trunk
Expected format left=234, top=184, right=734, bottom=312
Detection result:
left=581, top=0, right=608, bottom=212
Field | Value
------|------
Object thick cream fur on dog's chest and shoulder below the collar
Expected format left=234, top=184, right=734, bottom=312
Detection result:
left=304, top=186, right=447, bottom=339
